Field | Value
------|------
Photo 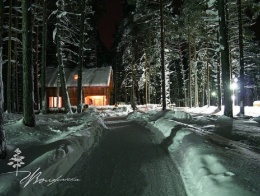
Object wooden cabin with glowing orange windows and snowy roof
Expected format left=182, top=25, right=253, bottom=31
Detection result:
left=46, top=66, right=113, bottom=108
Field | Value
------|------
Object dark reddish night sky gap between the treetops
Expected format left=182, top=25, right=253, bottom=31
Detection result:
left=97, top=0, right=122, bottom=48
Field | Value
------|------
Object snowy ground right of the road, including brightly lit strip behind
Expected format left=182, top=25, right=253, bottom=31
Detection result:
left=128, top=107, right=260, bottom=196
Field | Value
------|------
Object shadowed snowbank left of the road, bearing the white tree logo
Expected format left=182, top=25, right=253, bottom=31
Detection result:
left=0, top=109, right=106, bottom=195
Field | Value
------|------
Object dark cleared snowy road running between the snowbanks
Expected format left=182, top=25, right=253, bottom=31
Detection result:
left=56, top=118, right=186, bottom=196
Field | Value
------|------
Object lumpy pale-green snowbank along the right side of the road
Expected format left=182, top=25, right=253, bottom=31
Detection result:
left=128, top=108, right=260, bottom=196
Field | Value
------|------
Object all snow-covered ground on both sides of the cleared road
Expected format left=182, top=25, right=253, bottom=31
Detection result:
left=0, top=105, right=260, bottom=196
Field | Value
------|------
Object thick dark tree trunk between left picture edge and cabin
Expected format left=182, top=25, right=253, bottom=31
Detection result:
left=22, top=0, right=35, bottom=127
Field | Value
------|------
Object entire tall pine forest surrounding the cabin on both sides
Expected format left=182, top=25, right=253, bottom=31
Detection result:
left=0, top=0, right=260, bottom=149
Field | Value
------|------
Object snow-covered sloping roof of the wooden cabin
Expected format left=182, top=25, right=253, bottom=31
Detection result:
left=45, top=66, right=112, bottom=87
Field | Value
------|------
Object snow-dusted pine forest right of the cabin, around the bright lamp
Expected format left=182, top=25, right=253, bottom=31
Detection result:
left=113, top=0, right=259, bottom=116
